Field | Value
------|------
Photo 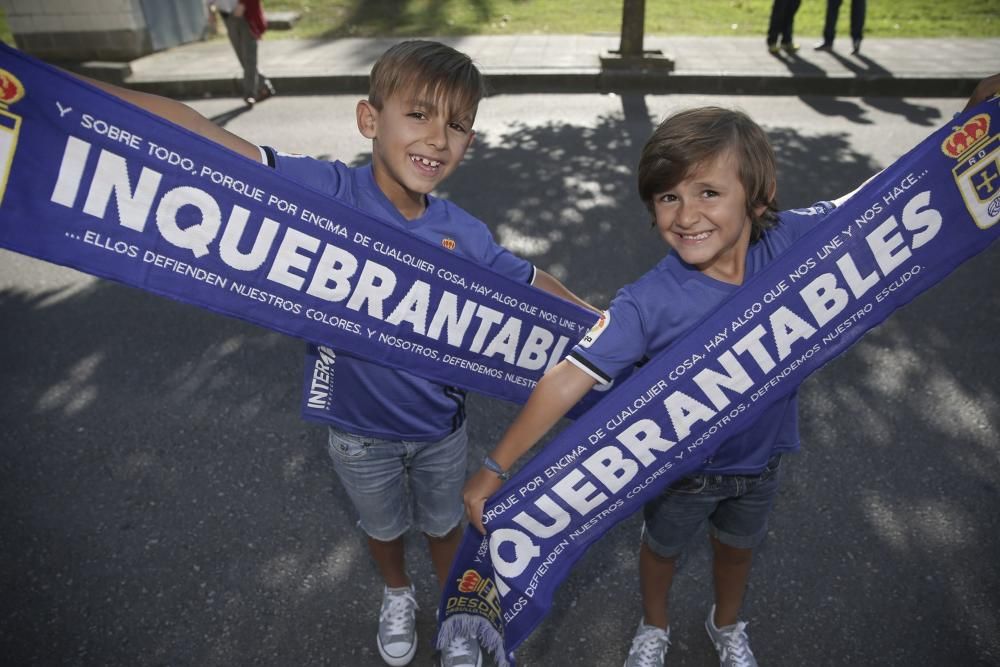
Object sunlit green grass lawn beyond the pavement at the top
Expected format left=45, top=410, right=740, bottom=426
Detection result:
left=265, top=0, right=1000, bottom=41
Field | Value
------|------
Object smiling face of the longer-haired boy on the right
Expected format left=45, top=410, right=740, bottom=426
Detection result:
left=653, top=151, right=764, bottom=285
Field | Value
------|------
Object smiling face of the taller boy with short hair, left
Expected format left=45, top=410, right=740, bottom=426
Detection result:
left=357, top=94, right=475, bottom=220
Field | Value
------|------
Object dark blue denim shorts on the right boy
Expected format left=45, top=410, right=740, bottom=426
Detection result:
left=642, top=454, right=781, bottom=558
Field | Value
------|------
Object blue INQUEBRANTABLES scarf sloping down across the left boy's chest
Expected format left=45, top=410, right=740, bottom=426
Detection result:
left=0, top=46, right=603, bottom=410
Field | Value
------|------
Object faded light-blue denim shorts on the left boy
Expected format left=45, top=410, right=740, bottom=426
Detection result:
left=328, top=424, right=469, bottom=542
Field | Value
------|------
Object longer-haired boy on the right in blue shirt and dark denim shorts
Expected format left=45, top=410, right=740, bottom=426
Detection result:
left=464, top=107, right=852, bottom=667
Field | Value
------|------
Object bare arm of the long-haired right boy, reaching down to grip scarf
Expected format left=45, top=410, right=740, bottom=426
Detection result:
left=462, top=359, right=596, bottom=534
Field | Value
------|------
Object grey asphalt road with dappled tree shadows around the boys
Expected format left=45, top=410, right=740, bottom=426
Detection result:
left=0, top=95, right=1000, bottom=667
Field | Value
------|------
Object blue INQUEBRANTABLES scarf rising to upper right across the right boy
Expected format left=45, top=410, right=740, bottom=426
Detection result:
left=437, top=99, right=1000, bottom=667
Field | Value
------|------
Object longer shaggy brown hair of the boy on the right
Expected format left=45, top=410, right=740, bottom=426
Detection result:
left=638, top=107, right=778, bottom=243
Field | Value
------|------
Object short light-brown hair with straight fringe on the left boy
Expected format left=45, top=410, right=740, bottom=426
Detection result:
left=368, top=40, right=486, bottom=124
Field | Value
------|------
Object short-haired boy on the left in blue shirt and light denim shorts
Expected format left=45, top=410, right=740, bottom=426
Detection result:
left=93, top=40, right=589, bottom=667
